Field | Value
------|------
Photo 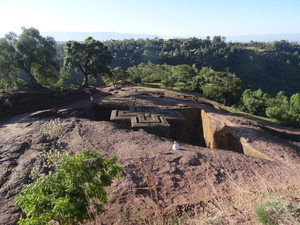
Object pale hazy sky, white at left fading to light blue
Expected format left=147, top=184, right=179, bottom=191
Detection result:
left=0, top=0, right=300, bottom=36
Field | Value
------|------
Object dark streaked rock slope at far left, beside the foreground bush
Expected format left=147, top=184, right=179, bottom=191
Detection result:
left=0, top=118, right=47, bottom=224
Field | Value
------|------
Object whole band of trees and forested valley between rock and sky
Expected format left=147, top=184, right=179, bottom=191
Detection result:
left=0, top=28, right=300, bottom=126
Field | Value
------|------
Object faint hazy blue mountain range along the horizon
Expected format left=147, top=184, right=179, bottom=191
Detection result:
left=0, top=32, right=300, bottom=43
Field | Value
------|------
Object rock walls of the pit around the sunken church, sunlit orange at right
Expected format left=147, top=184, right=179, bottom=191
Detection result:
left=82, top=103, right=272, bottom=160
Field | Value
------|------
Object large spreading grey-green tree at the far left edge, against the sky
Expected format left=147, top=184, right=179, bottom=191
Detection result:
left=0, top=27, right=59, bottom=87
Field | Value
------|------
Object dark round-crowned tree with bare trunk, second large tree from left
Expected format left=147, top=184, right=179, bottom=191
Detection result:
left=64, top=37, right=113, bottom=86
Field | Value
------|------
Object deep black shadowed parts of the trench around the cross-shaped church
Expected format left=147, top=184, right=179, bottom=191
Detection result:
left=81, top=104, right=243, bottom=153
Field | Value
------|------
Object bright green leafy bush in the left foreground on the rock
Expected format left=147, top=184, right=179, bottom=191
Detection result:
left=16, top=151, right=122, bottom=225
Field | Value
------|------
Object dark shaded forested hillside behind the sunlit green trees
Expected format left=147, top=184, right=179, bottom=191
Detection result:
left=105, top=36, right=300, bottom=96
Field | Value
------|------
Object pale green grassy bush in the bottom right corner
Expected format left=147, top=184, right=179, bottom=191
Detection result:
left=255, top=199, right=300, bottom=225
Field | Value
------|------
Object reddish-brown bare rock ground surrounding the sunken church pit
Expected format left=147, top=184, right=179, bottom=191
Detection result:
left=0, top=85, right=300, bottom=225
